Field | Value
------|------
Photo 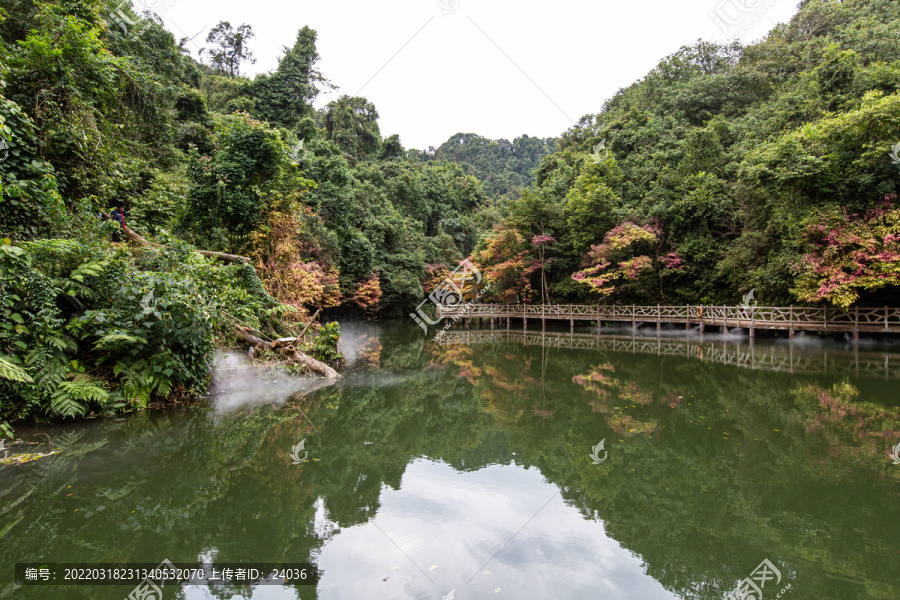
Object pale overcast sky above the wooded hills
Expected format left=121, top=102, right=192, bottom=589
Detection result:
left=153, top=0, right=797, bottom=149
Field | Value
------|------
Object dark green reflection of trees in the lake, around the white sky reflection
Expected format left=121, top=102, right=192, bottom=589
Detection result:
left=0, top=329, right=900, bottom=600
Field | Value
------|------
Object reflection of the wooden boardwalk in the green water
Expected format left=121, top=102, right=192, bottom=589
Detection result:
left=438, top=329, right=900, bottom=380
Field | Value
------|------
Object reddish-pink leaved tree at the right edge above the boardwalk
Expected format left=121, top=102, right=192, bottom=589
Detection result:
left=791, top=199, right=900, bottom=309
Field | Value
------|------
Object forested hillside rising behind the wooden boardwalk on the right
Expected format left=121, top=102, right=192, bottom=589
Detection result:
left=475, top=0, right=900, bottom=307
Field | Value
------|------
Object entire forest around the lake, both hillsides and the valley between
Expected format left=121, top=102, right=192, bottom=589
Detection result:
left=0, top=0, right=900, bottom=425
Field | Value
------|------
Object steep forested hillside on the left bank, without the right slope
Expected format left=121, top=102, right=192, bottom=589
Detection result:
left=0, top=0, right=495, bottom=430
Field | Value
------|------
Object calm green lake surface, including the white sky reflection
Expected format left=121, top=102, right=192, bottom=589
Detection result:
left=0, top=323, right=900, bottom=600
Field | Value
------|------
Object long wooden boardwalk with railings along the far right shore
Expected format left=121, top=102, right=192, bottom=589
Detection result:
left=438, top=303, right=900, bottom=340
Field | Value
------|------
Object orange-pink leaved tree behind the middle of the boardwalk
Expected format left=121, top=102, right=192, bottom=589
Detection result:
left=572, top=221, right=684, bottom=298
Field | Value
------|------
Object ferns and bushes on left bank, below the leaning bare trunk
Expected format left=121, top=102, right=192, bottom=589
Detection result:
left=0, top=233, right=280, bottom=420
